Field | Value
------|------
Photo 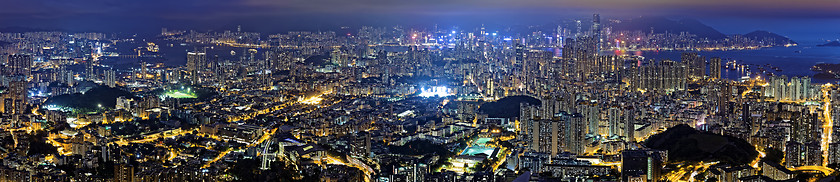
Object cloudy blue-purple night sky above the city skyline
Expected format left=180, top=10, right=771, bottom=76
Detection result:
left=0, top=0, right=840, bottom=38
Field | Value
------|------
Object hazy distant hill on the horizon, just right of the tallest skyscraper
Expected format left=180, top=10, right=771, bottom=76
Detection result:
left=613, top=17, right=727, bottom=40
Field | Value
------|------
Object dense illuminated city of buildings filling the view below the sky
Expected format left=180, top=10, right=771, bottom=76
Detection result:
left=0, top=14, right=840, bottom=182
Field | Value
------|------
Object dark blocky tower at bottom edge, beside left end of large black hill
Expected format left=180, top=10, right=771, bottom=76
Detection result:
left=621, top=150, right=668, bottom=181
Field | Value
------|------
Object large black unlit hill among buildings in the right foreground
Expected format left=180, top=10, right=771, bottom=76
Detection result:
left=644, top=124, right=758, bottom=165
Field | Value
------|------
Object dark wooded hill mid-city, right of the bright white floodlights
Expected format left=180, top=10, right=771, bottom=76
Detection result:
left=479, top=95, right=542, bottom=118
